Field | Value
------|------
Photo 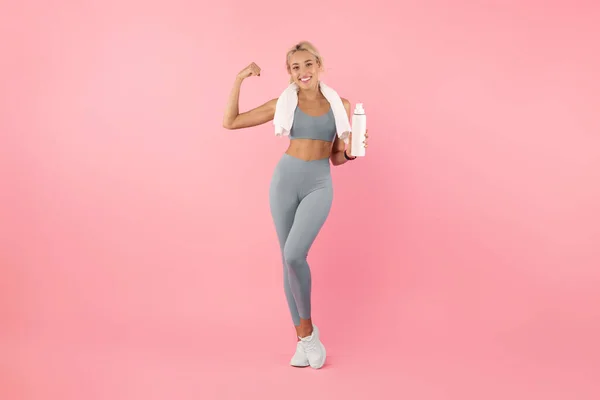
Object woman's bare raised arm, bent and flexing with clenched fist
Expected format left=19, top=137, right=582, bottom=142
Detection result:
left=223, top=63, right=277, bottom=129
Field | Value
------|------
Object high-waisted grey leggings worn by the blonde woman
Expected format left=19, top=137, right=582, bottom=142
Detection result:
left=269, top=153, right=333, bottom=326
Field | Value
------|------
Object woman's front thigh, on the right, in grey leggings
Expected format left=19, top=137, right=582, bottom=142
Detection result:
left=285, top=185, right=333, bottom=257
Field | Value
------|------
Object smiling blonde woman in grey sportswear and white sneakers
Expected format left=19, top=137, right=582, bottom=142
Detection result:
left=223, top=42, right=367, bottom=368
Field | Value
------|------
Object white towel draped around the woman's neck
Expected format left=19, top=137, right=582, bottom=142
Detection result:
left=273, top=81, right=351, bottom=144
